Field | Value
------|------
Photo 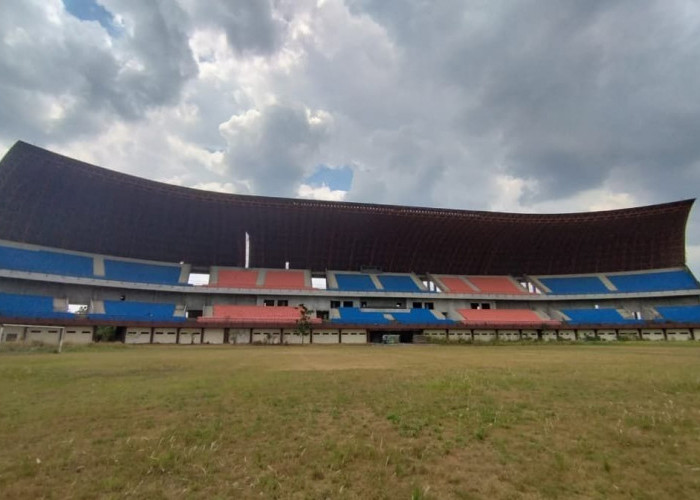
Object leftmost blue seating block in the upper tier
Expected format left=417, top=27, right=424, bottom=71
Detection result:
left=0, top=246, right=93, bottom=278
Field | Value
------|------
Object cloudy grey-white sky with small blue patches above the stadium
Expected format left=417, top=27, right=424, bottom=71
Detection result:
left=0, top=0, right=700, bottom=274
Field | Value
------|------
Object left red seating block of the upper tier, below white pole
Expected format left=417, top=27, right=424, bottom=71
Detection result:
left=209, top=267, right=311, bottom=290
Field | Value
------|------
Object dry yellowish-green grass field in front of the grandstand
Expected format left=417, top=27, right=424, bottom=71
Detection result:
left=0, top=343, right=700, bottom=499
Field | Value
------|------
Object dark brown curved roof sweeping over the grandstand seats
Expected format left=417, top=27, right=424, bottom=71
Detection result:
left=0, top=142, right=694, bottom=275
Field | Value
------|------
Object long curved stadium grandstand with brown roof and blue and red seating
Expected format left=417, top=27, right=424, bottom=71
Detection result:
left=0, top=142, right=700, bottom=344
